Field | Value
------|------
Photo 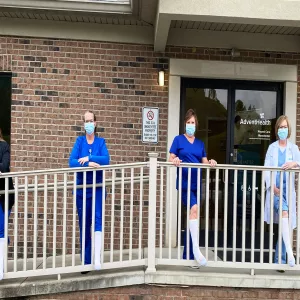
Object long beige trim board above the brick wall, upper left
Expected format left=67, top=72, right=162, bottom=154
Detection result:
left=0, top=18, right=153, bottom=44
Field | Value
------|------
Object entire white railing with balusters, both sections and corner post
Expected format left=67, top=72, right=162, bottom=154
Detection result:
left=0, top=153, right=300, bottom=278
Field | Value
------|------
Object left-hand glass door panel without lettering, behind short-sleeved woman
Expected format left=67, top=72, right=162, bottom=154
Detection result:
left=181, top=79, right=229, bottom=247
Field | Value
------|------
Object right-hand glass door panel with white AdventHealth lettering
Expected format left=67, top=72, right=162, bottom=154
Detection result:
left=229, top=84, right=282, bottom=262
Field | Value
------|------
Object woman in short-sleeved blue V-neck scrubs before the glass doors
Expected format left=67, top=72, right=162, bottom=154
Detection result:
left=169, top=109, right=217, bottom=266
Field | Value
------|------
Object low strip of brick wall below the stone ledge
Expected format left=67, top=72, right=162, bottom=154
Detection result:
left=26, top=285, right=300, bottom=300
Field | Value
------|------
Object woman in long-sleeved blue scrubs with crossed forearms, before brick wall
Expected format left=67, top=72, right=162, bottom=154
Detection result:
left=69, top=111, right=109, bottom=273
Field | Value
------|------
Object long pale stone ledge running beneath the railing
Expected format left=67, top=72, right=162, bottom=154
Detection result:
left=0, top=266, right=300, bottom=299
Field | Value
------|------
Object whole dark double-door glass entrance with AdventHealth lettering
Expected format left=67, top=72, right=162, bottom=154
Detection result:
left=180, top=78, right=283, bottom=261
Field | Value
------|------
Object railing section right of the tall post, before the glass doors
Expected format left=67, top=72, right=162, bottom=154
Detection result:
left=157, top=162, right=300, bottom=273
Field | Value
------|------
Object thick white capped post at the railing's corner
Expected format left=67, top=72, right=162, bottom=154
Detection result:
left=146, top=153, right=158, bottom=273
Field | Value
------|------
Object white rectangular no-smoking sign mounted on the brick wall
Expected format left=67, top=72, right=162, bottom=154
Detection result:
left=142, top=107, right=159, bottom=143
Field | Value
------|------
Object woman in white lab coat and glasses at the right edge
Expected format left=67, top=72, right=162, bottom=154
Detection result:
left=264, top=116, right=300, bottom=267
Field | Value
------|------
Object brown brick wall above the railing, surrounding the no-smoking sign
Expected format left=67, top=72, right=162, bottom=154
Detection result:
left=0, top=37, right=300, bottom=254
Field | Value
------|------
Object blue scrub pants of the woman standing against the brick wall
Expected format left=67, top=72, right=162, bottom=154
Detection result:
left=76, top=188, right=102, bottom=265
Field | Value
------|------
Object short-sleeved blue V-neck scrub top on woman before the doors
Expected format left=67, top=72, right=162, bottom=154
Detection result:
left=170, top=134, right=206, bottom=191
